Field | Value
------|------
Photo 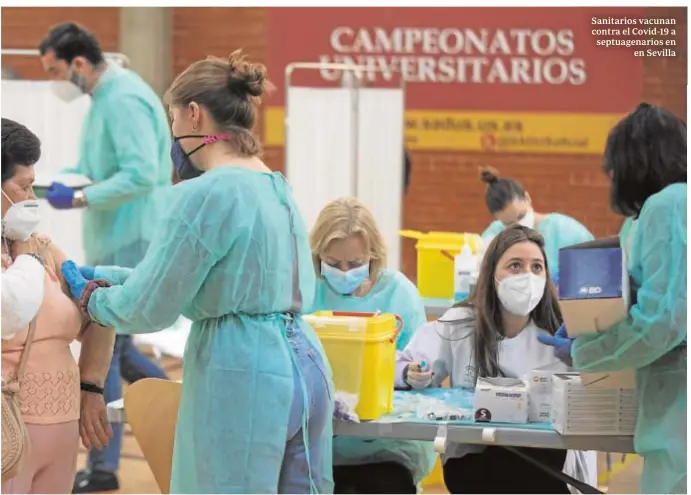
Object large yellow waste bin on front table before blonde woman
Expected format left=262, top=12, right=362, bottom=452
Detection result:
left=305, top=311, right=403, bottom=420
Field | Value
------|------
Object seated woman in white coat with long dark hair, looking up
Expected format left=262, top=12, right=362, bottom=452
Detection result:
left=396, top=225, right=594, bottom=493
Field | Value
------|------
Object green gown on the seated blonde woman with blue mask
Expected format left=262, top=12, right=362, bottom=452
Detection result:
left=311, top=270, right=437, bottom=483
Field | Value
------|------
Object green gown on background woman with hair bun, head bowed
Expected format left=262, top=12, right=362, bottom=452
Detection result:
left=482, top=213, right=594, bottom=275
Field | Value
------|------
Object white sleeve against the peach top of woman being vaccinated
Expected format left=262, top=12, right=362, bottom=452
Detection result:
left=1, top=255, right=45, bottom=340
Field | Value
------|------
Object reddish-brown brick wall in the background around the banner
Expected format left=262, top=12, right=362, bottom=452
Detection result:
left=2, top=7, right=687, bottom=277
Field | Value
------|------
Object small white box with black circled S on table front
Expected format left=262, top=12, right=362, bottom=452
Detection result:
left=474, top=378, right=528, bottom=423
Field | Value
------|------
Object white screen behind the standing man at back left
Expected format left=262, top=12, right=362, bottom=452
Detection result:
left=2, top=80, right=91, bottom=263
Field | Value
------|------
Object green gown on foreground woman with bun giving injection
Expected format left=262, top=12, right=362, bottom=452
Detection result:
left=89, top=167, right=333, bottom=493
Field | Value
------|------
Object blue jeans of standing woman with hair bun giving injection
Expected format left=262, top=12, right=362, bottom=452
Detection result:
left=278, top=323, right=332, bottom=493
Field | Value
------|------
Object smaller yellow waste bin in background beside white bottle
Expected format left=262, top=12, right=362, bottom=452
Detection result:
left=399, top=230, right=483, bottom=299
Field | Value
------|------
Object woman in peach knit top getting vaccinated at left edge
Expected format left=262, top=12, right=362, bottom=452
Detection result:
left=2, top=119, right=115, bottom=493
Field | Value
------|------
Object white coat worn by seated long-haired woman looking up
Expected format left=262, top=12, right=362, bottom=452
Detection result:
left=396, top=308, right=597, bottom=494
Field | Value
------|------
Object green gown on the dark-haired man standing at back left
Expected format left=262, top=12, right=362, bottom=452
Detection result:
left=67, top=64, right=173, bottom=267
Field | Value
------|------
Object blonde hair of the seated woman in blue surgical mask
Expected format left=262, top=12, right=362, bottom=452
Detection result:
left=310, top=198, right=386, bottom=282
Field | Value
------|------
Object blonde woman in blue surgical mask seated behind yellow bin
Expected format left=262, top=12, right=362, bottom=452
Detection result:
left=310, top=198, right=436, bottom=493
